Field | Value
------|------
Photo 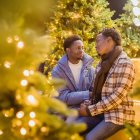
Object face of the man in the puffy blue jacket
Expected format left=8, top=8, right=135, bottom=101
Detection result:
left=67, top=40, right=84, bottom=60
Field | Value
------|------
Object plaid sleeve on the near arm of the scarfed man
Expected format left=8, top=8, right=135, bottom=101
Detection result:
left=88, top=63, right=135, bottom=116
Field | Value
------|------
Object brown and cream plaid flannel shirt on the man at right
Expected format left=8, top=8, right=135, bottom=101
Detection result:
left=88, top=52, right=135, bottom=125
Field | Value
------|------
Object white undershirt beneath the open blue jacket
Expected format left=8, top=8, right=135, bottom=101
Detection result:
left=68, top=60, right=83, bottom=85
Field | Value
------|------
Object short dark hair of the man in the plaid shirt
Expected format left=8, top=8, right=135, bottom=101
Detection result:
left=101, top=28, right=121, bottom=45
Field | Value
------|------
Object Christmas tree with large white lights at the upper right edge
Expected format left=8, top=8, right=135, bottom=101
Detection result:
left=116, top=0, right=140, bottom=57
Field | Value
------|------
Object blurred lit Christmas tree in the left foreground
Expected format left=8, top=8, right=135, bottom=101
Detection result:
left=0, top=0, right=85, bottom=140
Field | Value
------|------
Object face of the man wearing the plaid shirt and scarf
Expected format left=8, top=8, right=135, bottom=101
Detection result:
left=95, top=34, right=109, bottom=55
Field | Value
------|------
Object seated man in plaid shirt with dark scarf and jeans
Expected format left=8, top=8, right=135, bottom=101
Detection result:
left=79, top=28, right=135, bottom=140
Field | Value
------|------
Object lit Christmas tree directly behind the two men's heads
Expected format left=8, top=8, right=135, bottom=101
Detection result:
left=42, top=0, right=115, bottom=73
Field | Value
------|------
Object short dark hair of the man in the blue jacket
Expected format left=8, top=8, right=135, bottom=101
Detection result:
left=63, top=35, right=82, bottom=51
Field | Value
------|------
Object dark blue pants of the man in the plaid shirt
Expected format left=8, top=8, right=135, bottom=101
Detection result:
left=76, top=115, right=124, bottom=140
